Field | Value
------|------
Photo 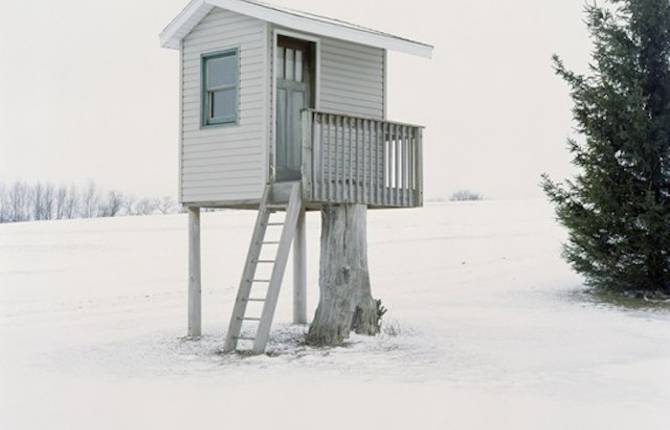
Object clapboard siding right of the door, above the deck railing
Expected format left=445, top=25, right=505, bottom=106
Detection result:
left=319, top=38, right=386, bottom=119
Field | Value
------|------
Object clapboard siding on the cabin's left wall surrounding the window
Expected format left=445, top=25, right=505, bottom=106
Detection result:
left=181, top=8, right=269, bottom=204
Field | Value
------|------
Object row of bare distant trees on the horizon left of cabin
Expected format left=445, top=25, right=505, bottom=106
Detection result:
left=0, top=181, right=179, bottom=224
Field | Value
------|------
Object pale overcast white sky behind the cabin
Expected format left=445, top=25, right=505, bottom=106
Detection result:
left=0, top=0, right=590, bottom=198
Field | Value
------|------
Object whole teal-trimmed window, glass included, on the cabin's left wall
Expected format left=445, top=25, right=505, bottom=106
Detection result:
left=201, top=49, right=240, bottom=127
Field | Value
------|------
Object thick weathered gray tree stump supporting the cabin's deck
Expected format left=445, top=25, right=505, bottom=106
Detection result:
left=306, top=205, right=379, bottom=346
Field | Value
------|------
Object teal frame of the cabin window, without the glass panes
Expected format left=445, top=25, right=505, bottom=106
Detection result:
left=200, top=47, right=242, bottom=128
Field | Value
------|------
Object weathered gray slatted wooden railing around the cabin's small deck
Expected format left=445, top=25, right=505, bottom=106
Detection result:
left=302, top=110, right=423, bottom=207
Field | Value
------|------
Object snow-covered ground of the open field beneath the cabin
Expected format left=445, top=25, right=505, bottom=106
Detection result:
left=0, top=201, right=670, bottom=429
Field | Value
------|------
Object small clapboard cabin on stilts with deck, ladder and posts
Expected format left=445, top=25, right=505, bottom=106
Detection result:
left=160, top=0, right=433, bottom=353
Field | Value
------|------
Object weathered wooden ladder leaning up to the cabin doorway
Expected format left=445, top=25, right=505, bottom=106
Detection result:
left=223, top=182, right=302, bottom=354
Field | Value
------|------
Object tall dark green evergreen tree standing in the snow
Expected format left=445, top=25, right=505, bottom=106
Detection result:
left=543, top=0, right=670, bottom=293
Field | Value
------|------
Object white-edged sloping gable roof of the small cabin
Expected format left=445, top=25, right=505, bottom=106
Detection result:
left=160, top=0, right=433, bottom=58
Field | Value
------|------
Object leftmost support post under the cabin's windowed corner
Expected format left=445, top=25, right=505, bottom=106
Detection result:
left=188, top=208, right=202, bottom=339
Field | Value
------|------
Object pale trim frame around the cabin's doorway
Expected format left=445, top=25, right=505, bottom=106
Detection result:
left=268, top=28, right=321, bottom=183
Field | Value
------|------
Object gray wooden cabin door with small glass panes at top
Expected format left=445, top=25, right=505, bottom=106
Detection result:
left=275, top=37, right=312, bottom=182
